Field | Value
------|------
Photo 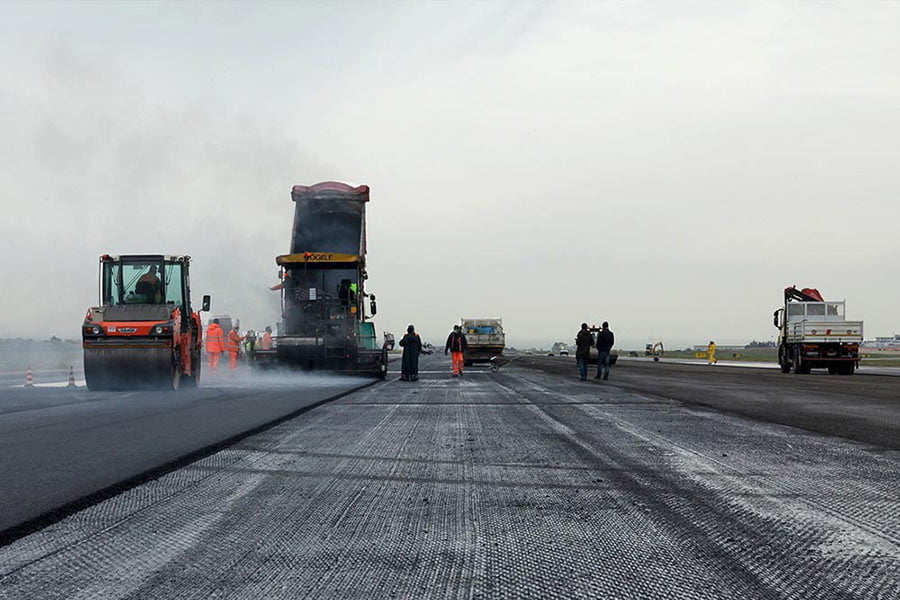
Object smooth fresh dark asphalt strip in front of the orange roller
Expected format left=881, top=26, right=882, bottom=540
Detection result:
left=0, top=369, right=372, bottom=540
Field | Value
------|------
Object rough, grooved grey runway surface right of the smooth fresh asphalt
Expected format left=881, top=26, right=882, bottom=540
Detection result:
left=0, top=356, right=900, bottom=600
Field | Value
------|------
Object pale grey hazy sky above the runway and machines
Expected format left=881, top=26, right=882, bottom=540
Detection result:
left=0, top=0, right=900, bottom=348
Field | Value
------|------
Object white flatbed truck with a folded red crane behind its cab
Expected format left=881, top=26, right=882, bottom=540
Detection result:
left=772, top=286, right=863, bottom=375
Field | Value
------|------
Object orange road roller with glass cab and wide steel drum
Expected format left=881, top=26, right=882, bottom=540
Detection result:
left=81, top=254, right=210, bottom=391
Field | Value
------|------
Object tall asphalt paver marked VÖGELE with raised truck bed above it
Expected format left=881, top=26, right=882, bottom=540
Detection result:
left=251, top=181, right=387, bottom=378
